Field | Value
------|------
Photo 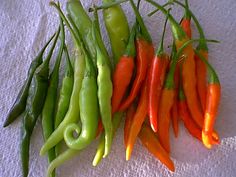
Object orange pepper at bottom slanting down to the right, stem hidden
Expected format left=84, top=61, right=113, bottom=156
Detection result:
left=138, top=123, right=175, bottom=172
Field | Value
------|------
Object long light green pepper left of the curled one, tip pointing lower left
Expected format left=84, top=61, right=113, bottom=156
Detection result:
left=40, top=2, right=85, bottom=155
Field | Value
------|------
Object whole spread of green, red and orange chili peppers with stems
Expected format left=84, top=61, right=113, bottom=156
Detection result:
left=4, top=0, right=221, bottom=177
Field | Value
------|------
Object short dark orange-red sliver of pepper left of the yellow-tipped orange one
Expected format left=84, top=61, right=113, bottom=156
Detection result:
left=124, top=104, right=136, bottom=148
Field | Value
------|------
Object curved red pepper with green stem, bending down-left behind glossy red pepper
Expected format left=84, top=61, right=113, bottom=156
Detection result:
left=119, top=0, right=154, bottom=111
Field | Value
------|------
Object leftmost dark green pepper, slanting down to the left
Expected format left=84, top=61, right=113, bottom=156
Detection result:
left=3, top=34, right=55, bottom=127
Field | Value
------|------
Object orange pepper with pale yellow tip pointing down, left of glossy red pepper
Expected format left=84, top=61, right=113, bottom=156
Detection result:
left=126, top=79, right=148, bottom=160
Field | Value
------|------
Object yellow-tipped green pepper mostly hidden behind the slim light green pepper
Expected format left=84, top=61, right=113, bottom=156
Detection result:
left=93, top=112, right=124, bottom=166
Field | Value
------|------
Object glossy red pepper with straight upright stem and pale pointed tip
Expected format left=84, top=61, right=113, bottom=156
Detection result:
left=148, top=14, right=169, bottom=132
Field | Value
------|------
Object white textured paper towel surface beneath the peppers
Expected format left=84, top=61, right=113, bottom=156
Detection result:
left=0, top=0, right=236, bottom=177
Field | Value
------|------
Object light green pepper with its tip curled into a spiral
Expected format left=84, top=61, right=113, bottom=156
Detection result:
left=64, top=13, right=99, bottom=150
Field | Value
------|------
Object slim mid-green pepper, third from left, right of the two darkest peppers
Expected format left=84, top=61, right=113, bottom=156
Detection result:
left=42, top=18, right=65, bottom=176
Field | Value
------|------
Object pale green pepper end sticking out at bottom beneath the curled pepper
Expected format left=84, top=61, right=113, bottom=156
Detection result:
left=47, top=149, right=80, bottom=177
